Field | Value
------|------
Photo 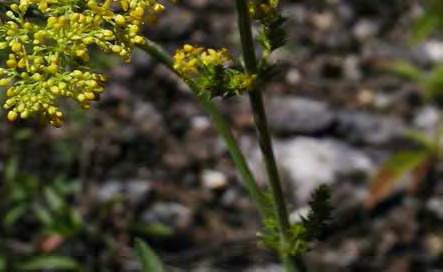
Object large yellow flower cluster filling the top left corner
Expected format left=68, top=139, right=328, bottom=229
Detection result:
left=0, top=0, right=164, bottom=126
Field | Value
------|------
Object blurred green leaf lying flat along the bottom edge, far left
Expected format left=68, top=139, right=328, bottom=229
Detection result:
left=17, top=255, right=80, bottom=271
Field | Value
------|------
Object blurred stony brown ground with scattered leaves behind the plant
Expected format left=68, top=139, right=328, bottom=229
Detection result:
left=0, top=0, right=443, bottom=272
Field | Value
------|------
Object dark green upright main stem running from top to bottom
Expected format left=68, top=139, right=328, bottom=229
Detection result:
left=235, top=0, right=296, bottom=271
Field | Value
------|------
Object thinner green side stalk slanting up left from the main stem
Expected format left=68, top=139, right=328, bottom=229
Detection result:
left=140, top=39, right=268, bottom=217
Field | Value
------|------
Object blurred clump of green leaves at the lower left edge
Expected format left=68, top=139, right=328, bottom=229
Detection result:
left=2, top=158, right=82, bottom=236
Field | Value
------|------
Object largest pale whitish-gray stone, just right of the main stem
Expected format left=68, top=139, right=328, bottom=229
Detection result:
left=275, top=137, right=375, bottom=203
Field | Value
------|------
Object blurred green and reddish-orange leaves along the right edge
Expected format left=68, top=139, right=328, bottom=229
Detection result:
left=374, top=0, right=443, bottom=207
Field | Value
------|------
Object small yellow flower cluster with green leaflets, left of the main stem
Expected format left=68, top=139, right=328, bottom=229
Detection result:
left=174, top=44, right=256, bottom=97
